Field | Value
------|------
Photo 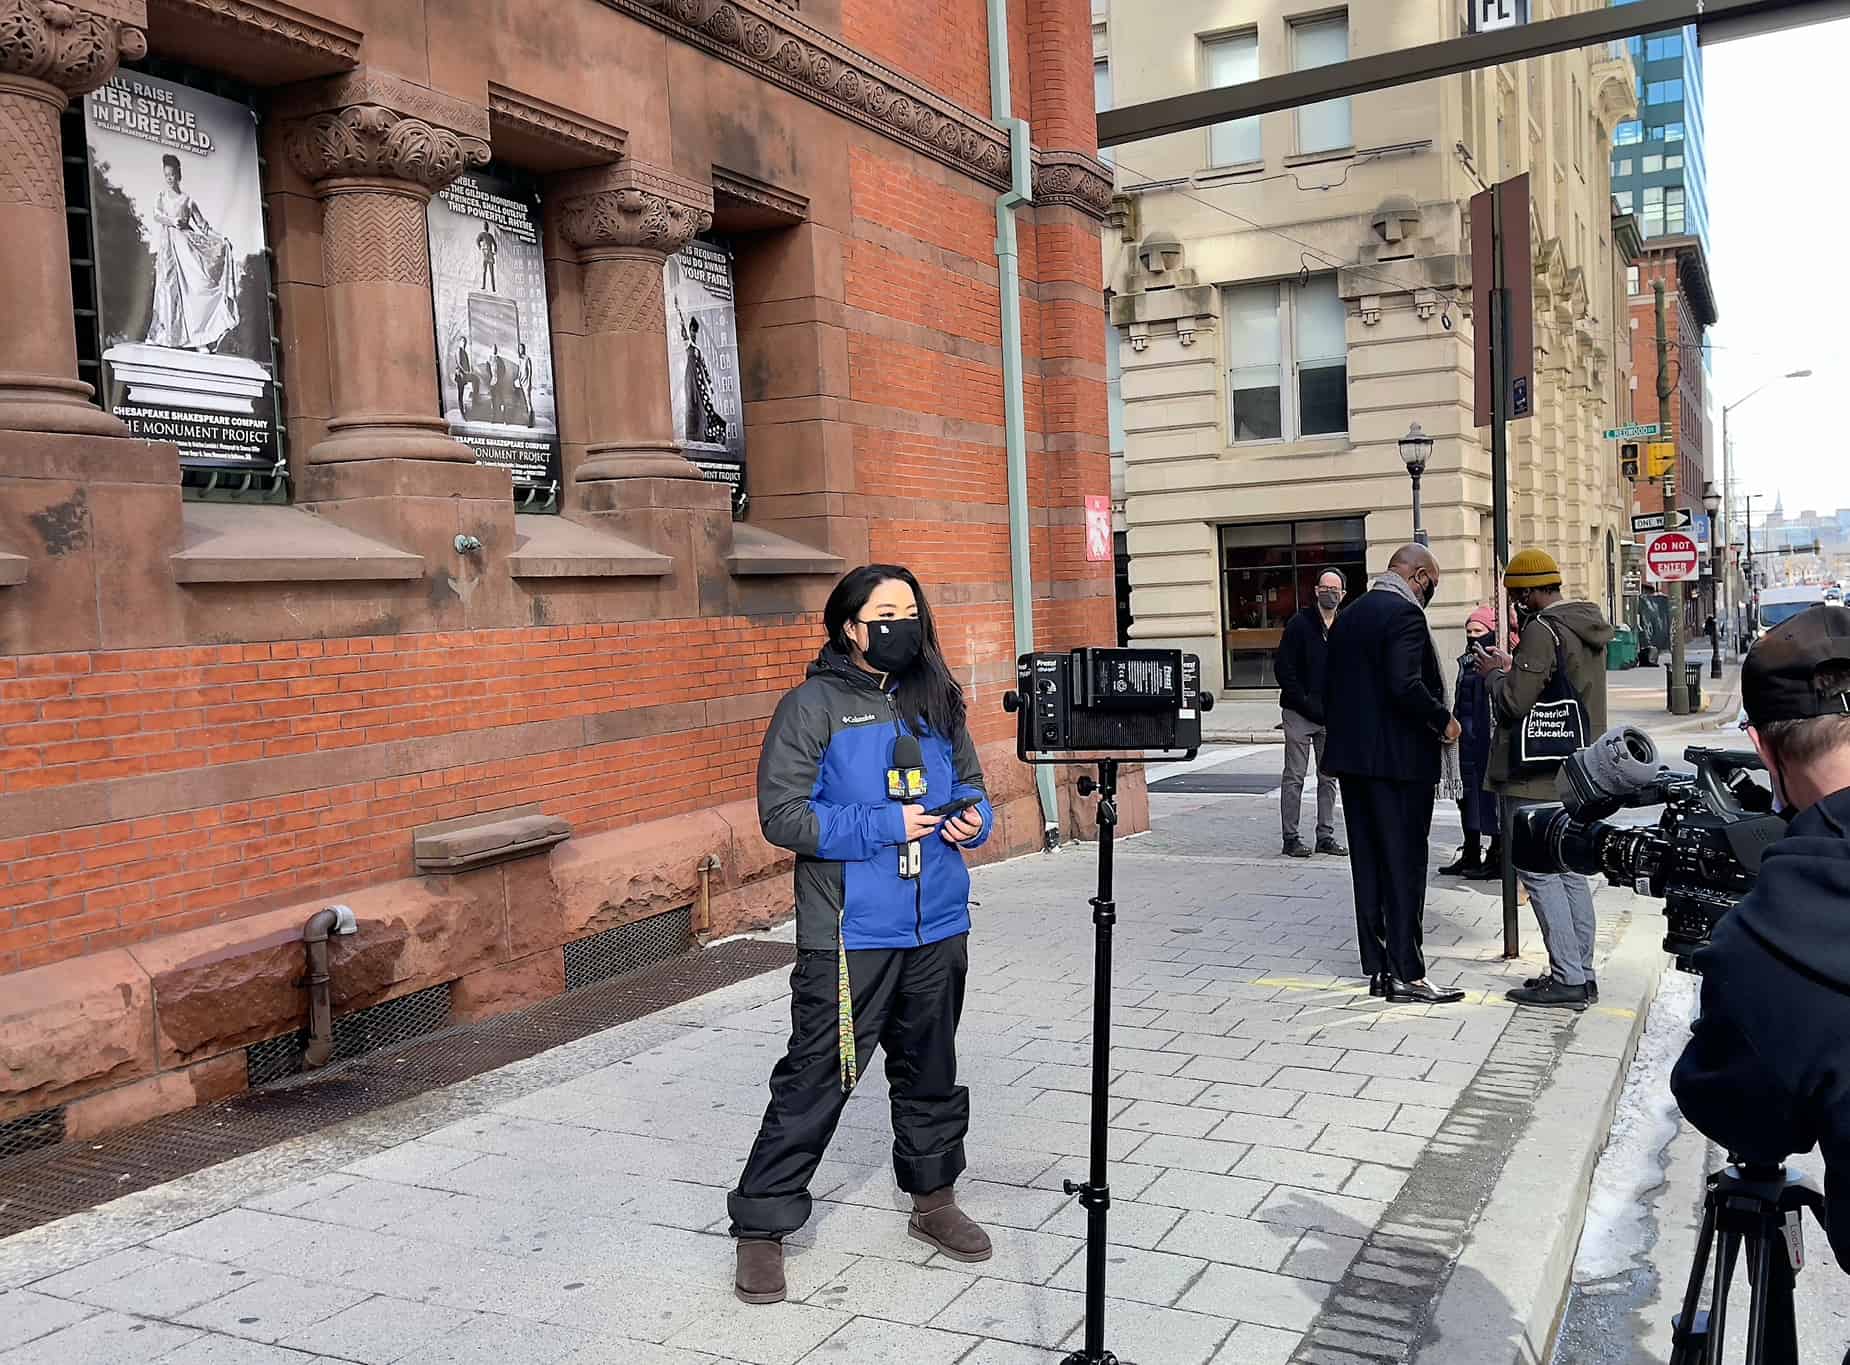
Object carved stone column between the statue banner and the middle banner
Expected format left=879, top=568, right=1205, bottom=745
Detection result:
left=283, top=68, right=488, bottom=464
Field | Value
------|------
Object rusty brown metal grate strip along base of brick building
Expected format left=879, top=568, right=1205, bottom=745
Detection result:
left=0, top=930, right=796, bottom=1237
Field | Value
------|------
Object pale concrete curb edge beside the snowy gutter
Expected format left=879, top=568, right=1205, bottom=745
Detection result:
left=1413, top=903, right=1667, bottom=1365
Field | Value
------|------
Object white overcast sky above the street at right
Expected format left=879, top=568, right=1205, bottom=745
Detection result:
left=1704, top=20, right=1850, bottom=520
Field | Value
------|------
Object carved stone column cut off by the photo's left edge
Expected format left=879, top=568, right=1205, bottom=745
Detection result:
left=0, top=0, right=148, bottom=437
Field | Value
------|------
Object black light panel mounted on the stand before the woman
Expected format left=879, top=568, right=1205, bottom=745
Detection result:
left=1003, top=649, right=1214, bottom=764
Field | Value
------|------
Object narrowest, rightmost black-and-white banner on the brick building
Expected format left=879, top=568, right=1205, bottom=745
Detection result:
left=662, top=240, right=746, bottom=516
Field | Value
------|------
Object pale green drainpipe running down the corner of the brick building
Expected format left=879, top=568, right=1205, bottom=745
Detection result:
left=988, top=0, right=1060, bottom=849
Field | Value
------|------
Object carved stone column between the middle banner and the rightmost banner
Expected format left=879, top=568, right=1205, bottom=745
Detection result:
left=559, top=161, right=712, bottom=483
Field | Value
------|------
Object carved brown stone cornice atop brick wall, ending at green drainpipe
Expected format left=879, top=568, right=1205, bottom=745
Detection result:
left=601, top=0, right=1008, bottom=189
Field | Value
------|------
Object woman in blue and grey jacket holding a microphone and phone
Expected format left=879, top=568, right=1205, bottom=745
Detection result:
left=727, top=564, right=993, bottom=1304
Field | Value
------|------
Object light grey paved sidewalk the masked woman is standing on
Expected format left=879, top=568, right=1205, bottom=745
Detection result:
left=0, top=776, right=1656, bottom=1365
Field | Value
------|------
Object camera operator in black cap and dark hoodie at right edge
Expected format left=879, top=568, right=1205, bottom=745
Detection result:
left=1671, top=607, right=1850, bottom=1271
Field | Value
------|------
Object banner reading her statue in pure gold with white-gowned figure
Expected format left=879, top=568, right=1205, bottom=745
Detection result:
left=83, top=70, right=283, bottom=470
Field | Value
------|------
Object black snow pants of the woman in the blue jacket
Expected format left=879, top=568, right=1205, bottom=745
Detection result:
left=725, top=934, right=969, bottom=1239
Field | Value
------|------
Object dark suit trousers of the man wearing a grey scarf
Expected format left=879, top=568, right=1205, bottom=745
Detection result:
left=1341, top=777, right=1434, bottom=980
